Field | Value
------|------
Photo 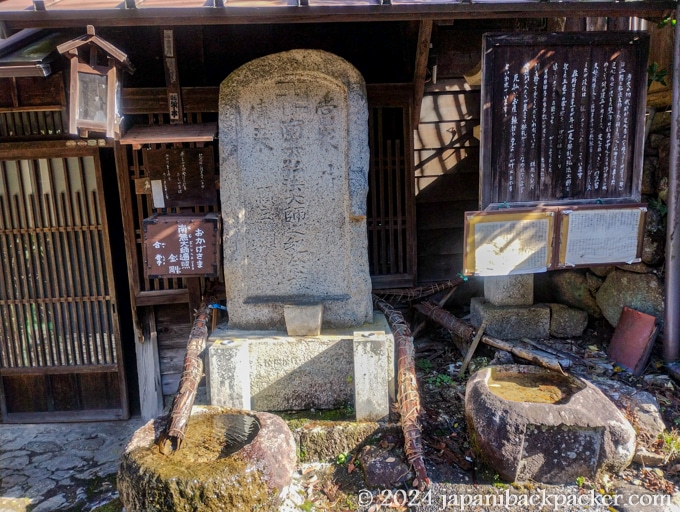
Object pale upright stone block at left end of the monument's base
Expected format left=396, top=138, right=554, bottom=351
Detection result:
left=206, top=338, right=250, bottom=409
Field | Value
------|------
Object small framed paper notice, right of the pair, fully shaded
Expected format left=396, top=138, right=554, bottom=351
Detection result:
left=557, top=204, right=647, bottom=268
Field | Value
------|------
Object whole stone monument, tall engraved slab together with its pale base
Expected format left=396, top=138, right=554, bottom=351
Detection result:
left=208, top=50, right=394, bottom=419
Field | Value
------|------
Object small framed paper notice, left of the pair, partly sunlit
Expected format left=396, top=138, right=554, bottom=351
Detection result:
left=463, top=209, right=556, bottom=276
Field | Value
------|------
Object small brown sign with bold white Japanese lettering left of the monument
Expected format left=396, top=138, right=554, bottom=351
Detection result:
left=142, top=213, right=221, bottom=278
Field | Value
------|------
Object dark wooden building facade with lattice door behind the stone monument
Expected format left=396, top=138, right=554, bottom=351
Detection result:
left=0, top=0, right=675, bottom=422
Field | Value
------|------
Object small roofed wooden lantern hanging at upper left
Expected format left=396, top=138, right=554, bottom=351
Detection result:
left=57, top=25, right=134, bottom=138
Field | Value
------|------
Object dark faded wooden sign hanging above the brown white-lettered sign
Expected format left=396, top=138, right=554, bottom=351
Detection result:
left=144, top=146, right=217, bottom=208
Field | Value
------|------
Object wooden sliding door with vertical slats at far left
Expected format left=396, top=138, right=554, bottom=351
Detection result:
left=0, top=146, right=128, bottom=422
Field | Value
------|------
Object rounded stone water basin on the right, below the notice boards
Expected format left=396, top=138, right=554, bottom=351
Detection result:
left=465, top=365, right=635, bottom=484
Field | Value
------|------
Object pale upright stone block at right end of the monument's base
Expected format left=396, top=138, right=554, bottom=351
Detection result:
left=354, top=332, right=390, bottom=421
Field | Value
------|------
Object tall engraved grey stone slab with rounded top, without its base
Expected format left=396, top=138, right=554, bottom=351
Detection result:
left=219, top=50, right=373, bottom=329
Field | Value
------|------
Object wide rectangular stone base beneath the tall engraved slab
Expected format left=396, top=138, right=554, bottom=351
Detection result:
left=208, top=313, right=396, bottom=417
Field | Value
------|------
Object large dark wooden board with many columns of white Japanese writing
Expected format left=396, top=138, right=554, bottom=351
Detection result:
left=480, top=32, right=649, bottom=209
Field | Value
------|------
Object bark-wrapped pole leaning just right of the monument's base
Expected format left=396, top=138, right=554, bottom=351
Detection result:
left=373, top=295, right=430, bottom=490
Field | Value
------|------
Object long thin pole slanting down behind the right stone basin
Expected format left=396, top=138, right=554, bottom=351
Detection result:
left=415, top=302, right=571, bottom=374
